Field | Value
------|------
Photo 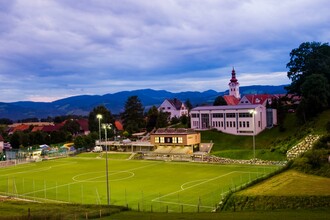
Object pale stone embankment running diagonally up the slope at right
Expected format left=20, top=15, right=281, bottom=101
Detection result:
left=286, top=134, right=320, bottom=160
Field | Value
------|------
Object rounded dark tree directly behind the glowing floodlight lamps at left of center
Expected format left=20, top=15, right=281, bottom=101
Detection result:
left=88, top=105, right=115, bottom=133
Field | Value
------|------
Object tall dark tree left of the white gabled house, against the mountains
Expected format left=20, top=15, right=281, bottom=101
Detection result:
left=121, top=96, right=145, bottom=134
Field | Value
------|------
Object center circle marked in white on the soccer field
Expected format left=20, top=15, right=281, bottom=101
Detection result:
left=72, top=171, right=135, bottom=183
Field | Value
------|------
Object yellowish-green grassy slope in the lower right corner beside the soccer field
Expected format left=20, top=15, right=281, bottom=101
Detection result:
left=225, top=170, right=330, bottom=211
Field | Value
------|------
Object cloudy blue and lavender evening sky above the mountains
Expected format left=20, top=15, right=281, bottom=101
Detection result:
left=0, top=0, right=330, bottom=102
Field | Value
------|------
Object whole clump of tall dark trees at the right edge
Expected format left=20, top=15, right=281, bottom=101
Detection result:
left=287, top=42, right=330, bottom=122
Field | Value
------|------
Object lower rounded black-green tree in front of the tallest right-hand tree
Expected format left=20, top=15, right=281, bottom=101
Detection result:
left=297, top=74, right=330, bottom=121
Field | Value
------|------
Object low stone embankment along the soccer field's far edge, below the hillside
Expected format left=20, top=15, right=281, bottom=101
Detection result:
left=207, top=156, right=287, bottom=166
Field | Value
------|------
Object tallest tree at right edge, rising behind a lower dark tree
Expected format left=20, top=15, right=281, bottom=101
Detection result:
left=287, top=42, right=330, bottom=95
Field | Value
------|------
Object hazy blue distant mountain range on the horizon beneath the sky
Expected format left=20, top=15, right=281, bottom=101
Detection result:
left=0, top=85, right=286, bottom=120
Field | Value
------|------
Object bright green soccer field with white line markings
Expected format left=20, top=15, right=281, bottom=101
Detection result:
left=0, top=156, right=279, bottom=212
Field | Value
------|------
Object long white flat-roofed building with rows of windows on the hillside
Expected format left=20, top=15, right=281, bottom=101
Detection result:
left=190, top=105, right=267, bottom=135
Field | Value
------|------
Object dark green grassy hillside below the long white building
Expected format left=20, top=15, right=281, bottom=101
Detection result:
left=202, top=110, right=330, bottom=160
